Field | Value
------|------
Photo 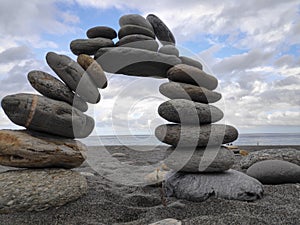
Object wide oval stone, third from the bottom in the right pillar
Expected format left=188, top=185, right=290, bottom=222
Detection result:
left=155, top=124, right=238, bottom=147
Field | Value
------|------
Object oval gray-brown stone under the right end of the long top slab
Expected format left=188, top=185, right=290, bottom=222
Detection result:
left=167, top=64, right=218, bottom=90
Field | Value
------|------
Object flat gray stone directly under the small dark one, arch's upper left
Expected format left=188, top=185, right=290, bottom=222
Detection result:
left=70, top=38, right=114, bottom=55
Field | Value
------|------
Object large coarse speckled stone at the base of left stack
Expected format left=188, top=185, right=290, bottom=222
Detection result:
left=0, top=169, right=88, bottom=213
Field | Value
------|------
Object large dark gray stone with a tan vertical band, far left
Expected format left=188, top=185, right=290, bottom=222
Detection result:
left=1, top=94, right=95, bottom=138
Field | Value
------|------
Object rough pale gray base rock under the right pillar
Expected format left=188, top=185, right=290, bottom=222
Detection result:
left=165, top=169, right=263, bottom=202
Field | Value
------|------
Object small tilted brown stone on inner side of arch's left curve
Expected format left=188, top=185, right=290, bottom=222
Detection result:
left=77, top=54, right=107, bottom=88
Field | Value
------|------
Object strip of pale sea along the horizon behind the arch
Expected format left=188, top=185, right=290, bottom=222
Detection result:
left=80, top=133, right=300, bottom=146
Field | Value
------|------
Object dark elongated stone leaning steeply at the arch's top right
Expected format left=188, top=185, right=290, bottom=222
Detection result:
left=147, top=14, right=175, bottom=45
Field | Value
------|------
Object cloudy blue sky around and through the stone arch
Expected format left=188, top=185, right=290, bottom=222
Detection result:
left=0, top=0, right=300, bottom=135
